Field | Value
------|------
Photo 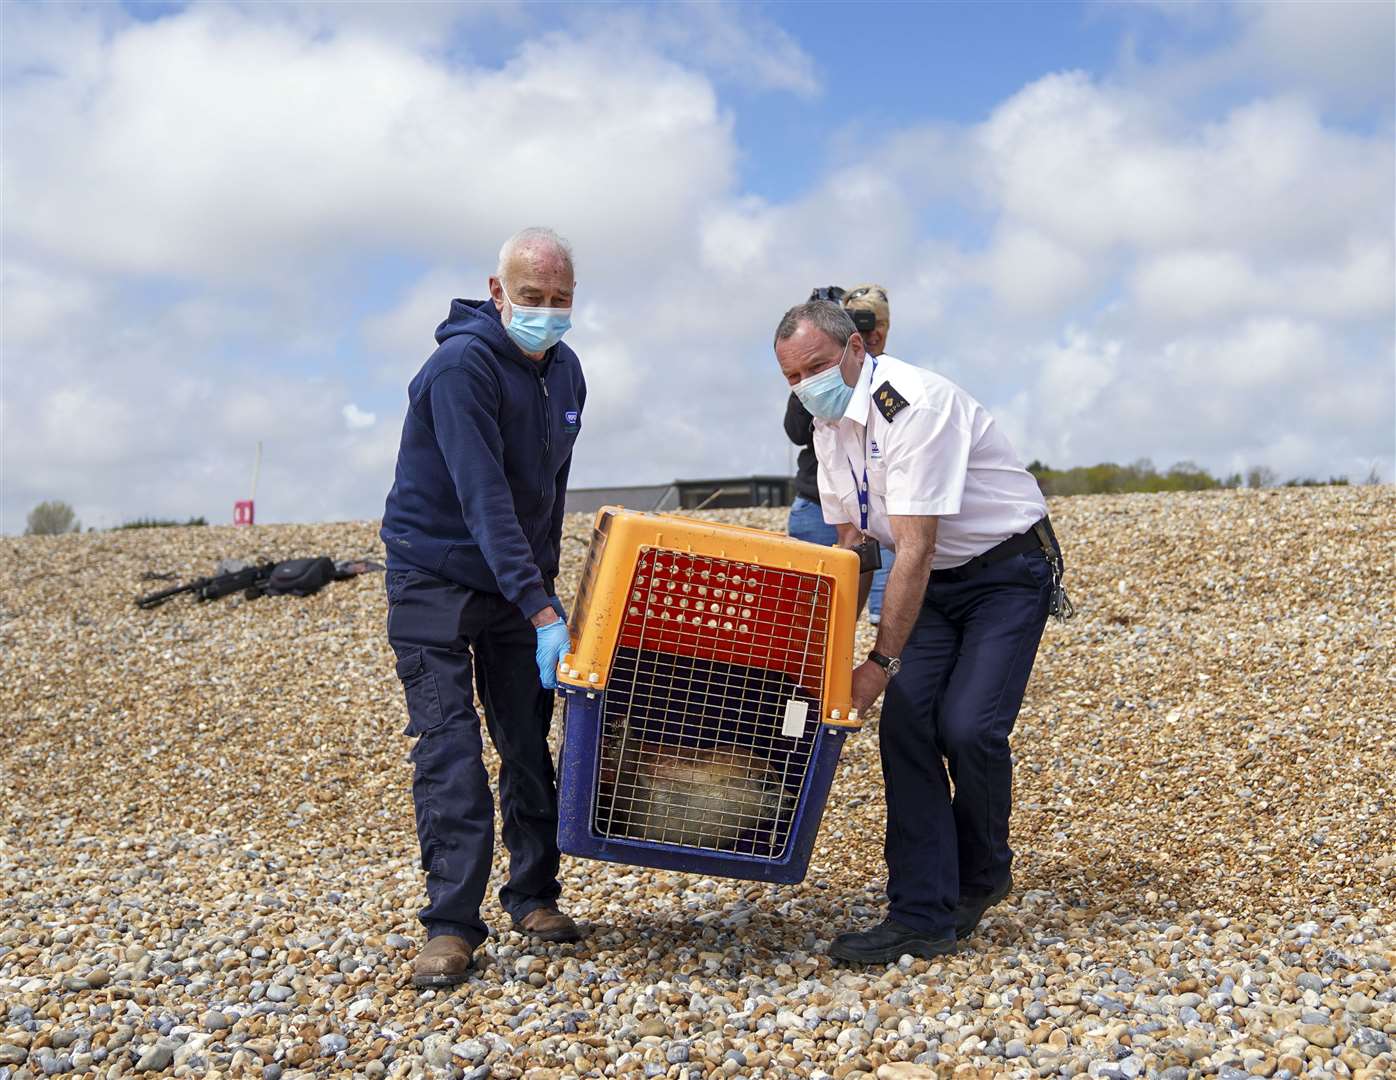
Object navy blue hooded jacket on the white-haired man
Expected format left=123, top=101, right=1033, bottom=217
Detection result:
left=381, top=300, right=586, bottom=615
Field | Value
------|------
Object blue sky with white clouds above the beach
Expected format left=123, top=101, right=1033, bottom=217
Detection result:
left=0, top=0, right=1396, bottom=533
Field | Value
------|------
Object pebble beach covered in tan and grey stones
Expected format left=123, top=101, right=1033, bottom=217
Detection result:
left=0, top=487, right=1396, bottom=1080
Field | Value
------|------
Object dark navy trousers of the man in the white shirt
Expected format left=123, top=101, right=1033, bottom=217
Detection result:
left=879, top=553, right=1051, bottom=938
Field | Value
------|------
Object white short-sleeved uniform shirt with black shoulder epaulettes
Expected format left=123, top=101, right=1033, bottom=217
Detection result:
left=814, top=353, right=1047, bottom=569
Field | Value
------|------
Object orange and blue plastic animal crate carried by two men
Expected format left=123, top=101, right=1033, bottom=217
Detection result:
left=558, top=507, right=859, bottom=882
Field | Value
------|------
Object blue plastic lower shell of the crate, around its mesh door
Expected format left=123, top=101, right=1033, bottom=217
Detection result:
left=557, top=687, right=847, bottom=885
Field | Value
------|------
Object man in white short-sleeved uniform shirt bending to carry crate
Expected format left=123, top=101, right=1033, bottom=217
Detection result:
left=775, top=301, right=1061, bottom=963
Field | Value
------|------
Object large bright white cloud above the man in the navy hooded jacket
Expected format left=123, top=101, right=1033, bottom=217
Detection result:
left=4, top=6, right=733, bottom=282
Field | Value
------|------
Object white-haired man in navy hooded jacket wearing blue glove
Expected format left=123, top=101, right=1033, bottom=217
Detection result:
left=383, top=229, right=586, bottom=987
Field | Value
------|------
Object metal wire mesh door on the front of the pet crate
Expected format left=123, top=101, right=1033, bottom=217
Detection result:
left=593, top=548, right=832, bottom=858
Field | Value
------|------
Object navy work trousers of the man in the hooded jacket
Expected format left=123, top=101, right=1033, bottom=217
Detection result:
left=387, top=571, right=561, bottom=945
